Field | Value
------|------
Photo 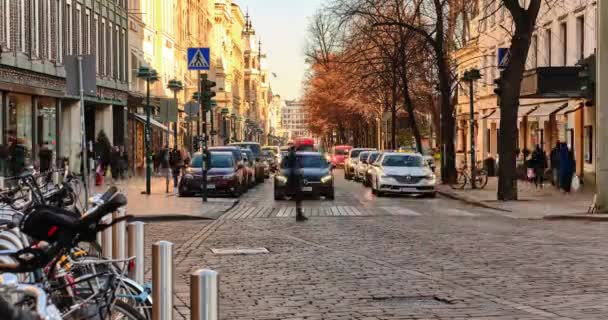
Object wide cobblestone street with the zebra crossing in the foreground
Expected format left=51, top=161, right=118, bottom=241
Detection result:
left=140, top=172, right=608, bottom=319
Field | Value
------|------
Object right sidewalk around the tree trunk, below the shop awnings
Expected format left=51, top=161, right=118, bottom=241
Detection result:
left=437, top=177, right=608, bottom=220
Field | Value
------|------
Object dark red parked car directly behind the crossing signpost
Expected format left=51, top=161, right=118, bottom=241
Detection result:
left=178, top=152, right=244, bottom=197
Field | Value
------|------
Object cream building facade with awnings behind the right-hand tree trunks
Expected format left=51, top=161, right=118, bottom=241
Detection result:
left=454, top=0, right=597, bottom=184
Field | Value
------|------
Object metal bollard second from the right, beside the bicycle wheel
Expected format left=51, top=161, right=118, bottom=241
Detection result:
left=152, top=241, right=173, bottom=320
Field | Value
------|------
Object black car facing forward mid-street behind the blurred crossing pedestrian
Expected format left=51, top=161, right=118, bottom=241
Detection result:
left=274, top=151, right=334, bottom=200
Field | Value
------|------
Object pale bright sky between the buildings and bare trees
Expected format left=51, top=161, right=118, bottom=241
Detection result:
left=234, top=0, right=324, bottom=99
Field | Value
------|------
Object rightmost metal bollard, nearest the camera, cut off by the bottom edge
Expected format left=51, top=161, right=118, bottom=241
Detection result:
left=190, top=269, right=220, bottom=320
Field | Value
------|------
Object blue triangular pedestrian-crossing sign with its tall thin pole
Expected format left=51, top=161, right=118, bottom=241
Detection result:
left=188, top=48, right=211, bottom=202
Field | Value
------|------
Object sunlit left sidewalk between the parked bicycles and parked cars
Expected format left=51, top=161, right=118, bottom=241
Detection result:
left=91, top=177, right=238, bottom=221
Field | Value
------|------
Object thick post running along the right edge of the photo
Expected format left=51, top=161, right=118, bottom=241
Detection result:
left=595, top=0, right=608, bottom=212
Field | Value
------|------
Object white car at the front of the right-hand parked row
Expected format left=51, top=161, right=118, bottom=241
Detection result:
left=371, top=152, right=437, bottom=198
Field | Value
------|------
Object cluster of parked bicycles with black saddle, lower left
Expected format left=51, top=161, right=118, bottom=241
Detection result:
left=0, top=171, right=152, bottom=320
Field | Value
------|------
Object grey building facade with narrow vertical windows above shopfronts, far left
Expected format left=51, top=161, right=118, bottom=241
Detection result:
left=0, top=0, right=128, bottom=182
